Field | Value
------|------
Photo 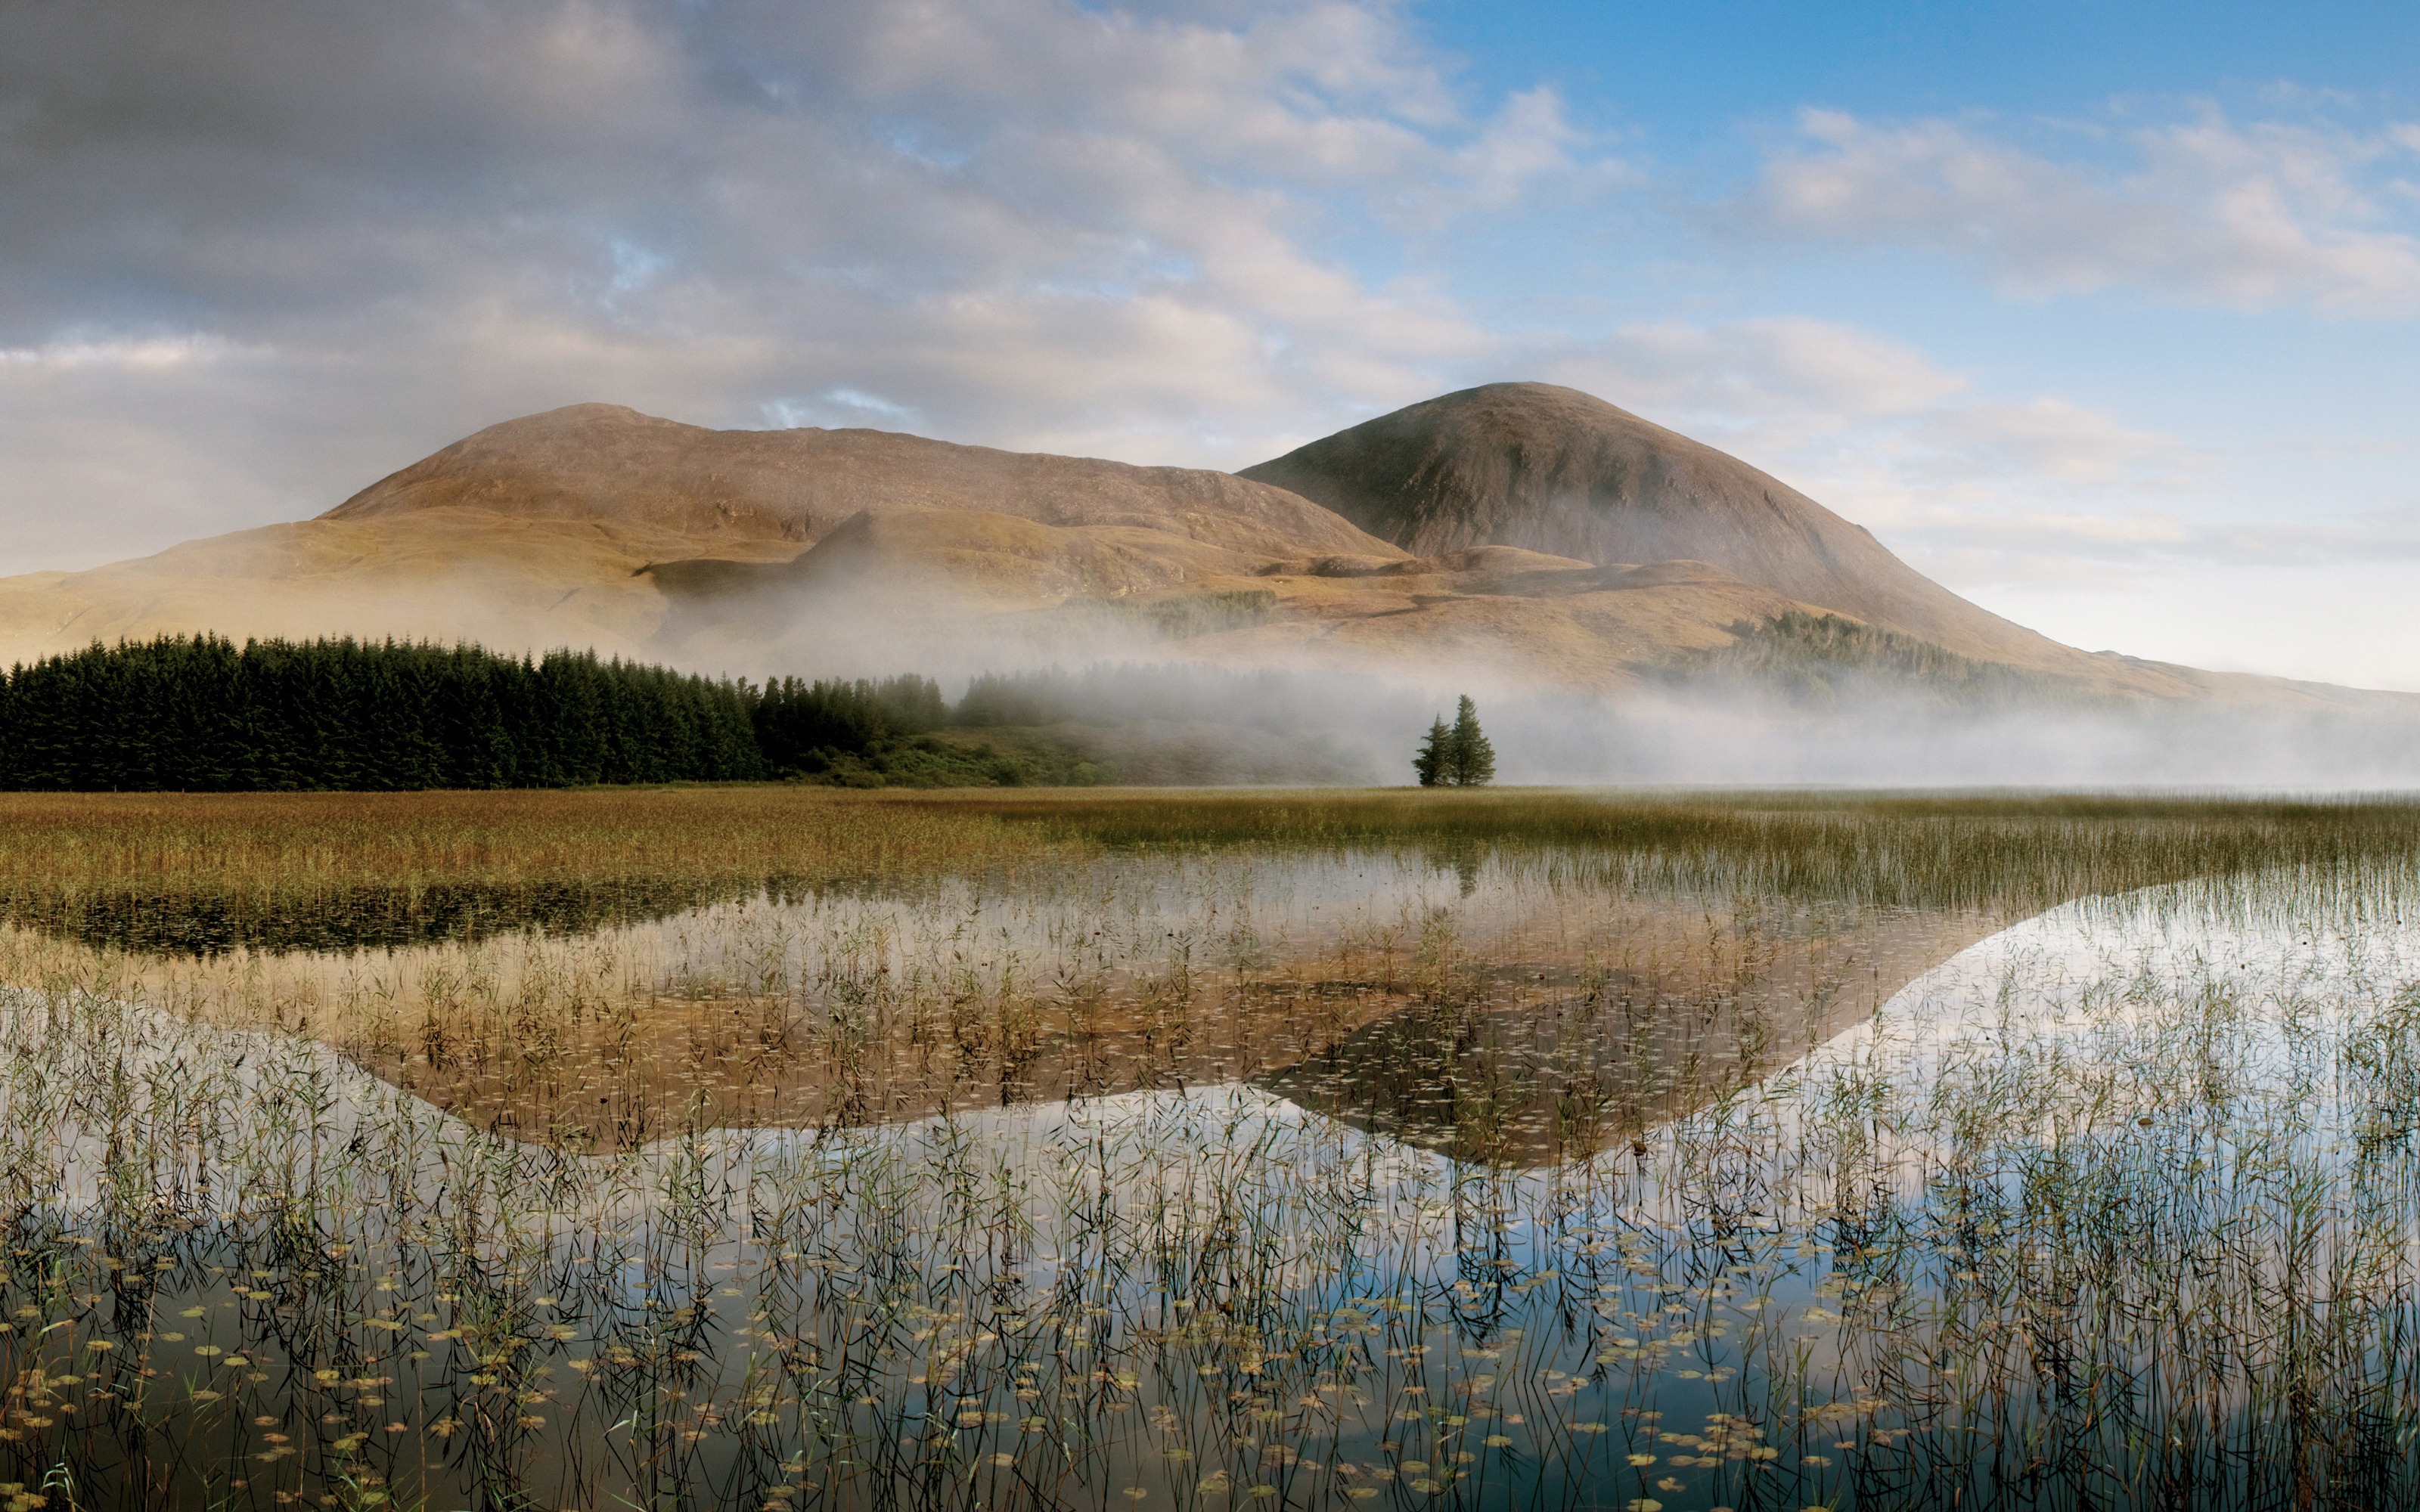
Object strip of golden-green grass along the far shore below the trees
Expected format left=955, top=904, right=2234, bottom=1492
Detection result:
left=0, top=786, right=2420, bottom=905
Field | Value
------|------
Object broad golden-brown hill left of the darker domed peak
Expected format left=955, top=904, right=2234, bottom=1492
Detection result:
left=0, top=404, right=1401, bottom=673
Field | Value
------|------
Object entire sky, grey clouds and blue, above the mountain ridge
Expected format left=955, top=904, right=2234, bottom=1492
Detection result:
left=0, top=0, right=2420, bottom=689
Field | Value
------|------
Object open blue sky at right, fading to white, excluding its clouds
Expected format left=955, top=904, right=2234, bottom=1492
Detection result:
left=1418, top=5, right=2420, bottom=687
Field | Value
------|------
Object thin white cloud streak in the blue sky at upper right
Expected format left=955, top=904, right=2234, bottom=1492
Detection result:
left=1723, top=109, right=2420, bottom=317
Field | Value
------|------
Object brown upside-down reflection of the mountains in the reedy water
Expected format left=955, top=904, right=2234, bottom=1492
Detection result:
left=0, top=844, right=2042, bottom=1163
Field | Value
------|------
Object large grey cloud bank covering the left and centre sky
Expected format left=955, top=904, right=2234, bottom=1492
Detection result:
left=0, top=0, right=1621, bottom=566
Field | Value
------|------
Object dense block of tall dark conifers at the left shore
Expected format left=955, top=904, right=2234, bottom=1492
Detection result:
left=0, top=637, right=765, bottom=791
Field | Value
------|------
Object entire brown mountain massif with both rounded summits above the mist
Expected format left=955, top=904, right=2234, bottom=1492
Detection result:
left=0, top=383, right=2391, bottom=711
